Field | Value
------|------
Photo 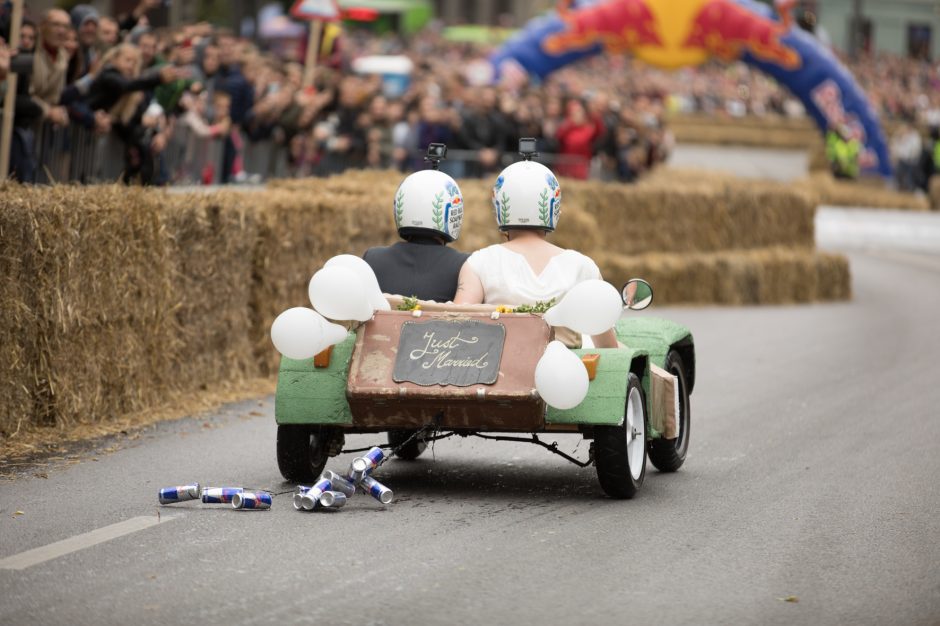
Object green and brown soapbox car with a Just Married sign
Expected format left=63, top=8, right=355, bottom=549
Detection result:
left=275, top=283, right=695, bottom=498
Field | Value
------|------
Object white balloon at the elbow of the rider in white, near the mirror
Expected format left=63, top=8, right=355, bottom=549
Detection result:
left=544, top=279, right=623, bottom=335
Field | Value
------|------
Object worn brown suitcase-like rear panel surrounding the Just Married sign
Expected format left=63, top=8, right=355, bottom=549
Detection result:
left=346, top=311, right=551, bottom=432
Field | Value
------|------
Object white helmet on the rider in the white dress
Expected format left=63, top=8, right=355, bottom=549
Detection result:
left=493, top=161, right=561, bottom=232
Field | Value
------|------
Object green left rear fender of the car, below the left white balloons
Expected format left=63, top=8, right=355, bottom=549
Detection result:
left=274, top=333, right=356, bottom=424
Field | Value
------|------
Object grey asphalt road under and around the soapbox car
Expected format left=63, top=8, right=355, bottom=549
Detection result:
left=0, top=245, right=940, bottom=626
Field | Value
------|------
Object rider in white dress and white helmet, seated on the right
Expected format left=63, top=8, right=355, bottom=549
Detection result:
left=454, top=161, right=617, bottom=348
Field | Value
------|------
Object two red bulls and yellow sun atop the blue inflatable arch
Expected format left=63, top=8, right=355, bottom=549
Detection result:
left=542, top=0, right=802, bottom=70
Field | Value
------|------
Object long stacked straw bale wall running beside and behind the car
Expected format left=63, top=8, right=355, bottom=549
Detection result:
left=0, top=172, right=849, bottom=435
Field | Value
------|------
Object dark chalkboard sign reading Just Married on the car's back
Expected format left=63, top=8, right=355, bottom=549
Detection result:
left=392, top=320, right=506, bottom=387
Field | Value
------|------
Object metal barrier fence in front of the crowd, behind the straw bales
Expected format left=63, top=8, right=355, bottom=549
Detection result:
left=20, top=120, right=604, bottom=185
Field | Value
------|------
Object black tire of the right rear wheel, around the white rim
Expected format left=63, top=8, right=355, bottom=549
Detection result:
left=594, top=372, right=647, bottom=499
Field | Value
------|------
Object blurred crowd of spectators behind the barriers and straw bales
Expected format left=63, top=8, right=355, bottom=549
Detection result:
left=0, top=0, right=940, bottom=184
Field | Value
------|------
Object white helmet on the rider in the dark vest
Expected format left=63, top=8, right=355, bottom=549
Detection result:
left=392, top=170, right=463, bottom=241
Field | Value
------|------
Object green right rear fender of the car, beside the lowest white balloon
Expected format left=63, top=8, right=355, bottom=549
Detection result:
left=545, top=348, right=643, bottom=426
